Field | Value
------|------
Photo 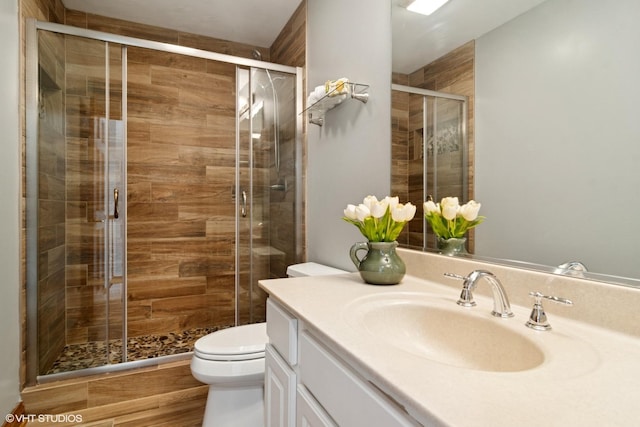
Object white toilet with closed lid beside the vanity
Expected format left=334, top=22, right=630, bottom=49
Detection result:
left=191, top=262, right=346, bottom=427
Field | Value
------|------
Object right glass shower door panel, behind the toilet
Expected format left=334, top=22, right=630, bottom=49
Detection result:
left=235, top=68, right=299, bottom=324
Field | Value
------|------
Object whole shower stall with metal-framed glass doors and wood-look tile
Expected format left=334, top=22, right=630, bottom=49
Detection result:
left=24, top=21, right=302, bottom=384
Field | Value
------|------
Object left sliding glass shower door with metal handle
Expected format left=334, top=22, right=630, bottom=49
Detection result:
left=26, top=30, right=125, bottom=379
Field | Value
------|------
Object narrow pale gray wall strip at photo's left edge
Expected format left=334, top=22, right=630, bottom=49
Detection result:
left=0, top=0, right=20, bottom=421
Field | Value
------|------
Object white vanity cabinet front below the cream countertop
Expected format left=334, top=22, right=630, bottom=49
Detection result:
left=265, top=299, right=418, bottom=427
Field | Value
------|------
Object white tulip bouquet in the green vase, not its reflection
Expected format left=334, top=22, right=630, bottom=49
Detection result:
left=342, top=196, right=416, bottom=242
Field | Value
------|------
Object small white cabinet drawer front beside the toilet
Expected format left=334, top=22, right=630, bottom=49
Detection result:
left=267, top=298, right=298, bottom=366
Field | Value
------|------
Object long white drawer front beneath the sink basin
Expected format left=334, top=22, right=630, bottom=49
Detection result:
left=299, top=331, right=418, bottom=427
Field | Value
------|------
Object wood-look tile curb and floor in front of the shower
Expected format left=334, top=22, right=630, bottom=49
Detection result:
left=22, top=360, right=208, bottom=427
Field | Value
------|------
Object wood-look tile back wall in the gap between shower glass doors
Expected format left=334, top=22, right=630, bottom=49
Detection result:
left=127, top=48, right=235, bottom=336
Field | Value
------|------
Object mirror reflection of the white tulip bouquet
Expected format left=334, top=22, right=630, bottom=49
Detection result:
left=424, top=197, right=485, bottom=239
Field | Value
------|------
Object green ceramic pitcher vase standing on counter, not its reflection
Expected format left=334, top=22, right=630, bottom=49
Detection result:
left=349, top=242, right=407, bottom=285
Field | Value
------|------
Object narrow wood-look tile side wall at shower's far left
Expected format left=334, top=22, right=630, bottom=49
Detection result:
left=38, top=28, right=67, bottom=370
